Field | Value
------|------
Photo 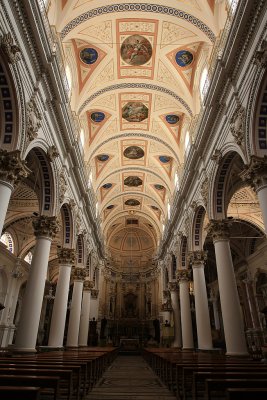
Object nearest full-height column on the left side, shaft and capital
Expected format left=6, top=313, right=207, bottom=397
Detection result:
left=14, top=215, right=59, bottom=352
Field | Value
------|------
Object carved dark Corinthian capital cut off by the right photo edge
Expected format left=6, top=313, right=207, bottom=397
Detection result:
left=239, top=156, right=267, bottom=191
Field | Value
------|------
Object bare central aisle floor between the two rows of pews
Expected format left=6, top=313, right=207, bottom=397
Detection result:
left=88, top=355, right=176, bottom=400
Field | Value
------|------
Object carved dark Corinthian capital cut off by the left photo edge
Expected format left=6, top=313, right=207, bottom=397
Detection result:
left=0, top=149, right=31, bottom=186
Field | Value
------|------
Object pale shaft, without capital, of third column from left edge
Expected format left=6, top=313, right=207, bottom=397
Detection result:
left=48, top=265, right=71, bottom=347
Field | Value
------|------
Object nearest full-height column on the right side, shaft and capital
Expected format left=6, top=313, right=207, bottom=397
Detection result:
left=207, top=220, right=247, bottom=355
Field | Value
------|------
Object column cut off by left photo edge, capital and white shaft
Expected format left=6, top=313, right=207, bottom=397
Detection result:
left=0, top=149, right=30, bottom=236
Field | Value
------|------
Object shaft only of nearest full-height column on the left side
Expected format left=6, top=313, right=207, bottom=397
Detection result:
left=15, top=237, right=51, bottom=351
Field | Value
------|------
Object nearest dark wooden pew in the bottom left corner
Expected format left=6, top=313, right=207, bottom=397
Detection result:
left=0, top=386, right=40, bottom=400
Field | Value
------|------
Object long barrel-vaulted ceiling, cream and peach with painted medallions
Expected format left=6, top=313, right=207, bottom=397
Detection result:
left=48, top=0, right=229, bottom=268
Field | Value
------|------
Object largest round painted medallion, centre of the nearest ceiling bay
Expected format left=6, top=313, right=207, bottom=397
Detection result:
left=121, top=35, right=152, bottom=65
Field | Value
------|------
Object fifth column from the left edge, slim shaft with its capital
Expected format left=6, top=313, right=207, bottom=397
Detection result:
left=79, top=280, right=94, bottom=346
